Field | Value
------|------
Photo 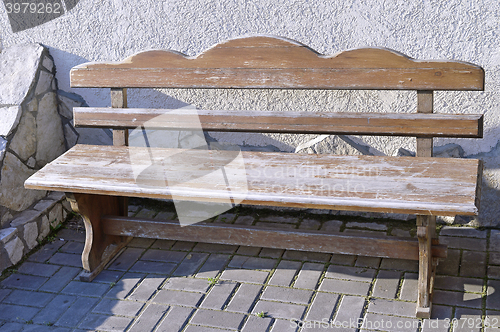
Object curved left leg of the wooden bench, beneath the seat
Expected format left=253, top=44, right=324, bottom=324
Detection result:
left=68, top=193, right=132, bottom=281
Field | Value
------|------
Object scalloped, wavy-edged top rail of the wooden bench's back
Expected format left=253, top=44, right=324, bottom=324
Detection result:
left=71, top=36, right=484, bottom=90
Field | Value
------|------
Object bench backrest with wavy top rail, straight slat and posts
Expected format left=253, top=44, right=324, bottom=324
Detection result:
left=71, top=36, right=484, bottom=156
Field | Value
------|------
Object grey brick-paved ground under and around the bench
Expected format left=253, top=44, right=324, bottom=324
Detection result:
left=0, top=200, right=500, bottom=332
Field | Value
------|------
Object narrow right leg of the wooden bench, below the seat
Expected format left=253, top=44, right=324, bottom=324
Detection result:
left=416, top=216, right=437, bottom=318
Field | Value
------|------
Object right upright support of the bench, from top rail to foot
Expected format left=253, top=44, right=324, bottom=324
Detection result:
left=416, top=91, right=439, bottom=318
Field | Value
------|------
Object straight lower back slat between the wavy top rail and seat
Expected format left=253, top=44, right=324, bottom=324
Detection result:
left=74, top=107, right=483, bottom=138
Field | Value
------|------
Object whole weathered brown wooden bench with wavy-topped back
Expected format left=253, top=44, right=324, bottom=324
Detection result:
left=25, top=36, right=484, bottom=317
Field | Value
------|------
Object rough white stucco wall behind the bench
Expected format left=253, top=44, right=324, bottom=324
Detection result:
left=0, top=0, right=500, bottom=225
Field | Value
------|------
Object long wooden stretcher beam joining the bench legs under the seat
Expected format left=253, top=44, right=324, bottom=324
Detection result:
left=103, top=216, right=447, bottom=260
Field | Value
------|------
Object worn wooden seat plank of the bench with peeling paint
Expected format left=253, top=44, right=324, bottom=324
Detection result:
left=25, top=145, right=479, bottom=215
